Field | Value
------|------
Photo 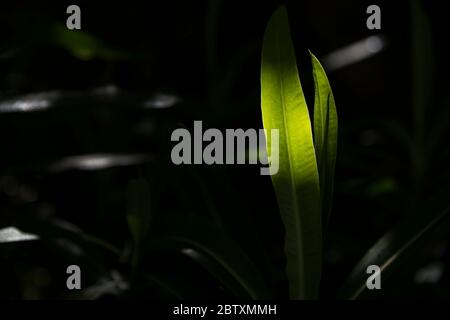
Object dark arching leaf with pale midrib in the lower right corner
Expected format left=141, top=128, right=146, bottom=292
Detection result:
left=339, top=207, right=450, bottom=300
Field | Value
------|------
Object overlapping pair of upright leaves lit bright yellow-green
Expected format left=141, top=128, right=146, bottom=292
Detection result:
left=261, top=7, right=337, bottom=299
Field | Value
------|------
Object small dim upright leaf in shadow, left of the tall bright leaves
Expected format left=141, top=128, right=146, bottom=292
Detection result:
left=127, top=178, right=151, bottom=268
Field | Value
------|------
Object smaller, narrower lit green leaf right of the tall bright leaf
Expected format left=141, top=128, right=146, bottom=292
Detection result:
left=310, top=52, right=338, bottom=231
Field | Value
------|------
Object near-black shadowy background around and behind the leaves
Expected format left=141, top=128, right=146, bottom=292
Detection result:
left=0, top=0, right=450, bottom=299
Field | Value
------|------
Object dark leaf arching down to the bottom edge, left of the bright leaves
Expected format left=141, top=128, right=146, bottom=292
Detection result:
left=149, top=214, right=270, bottom=299
